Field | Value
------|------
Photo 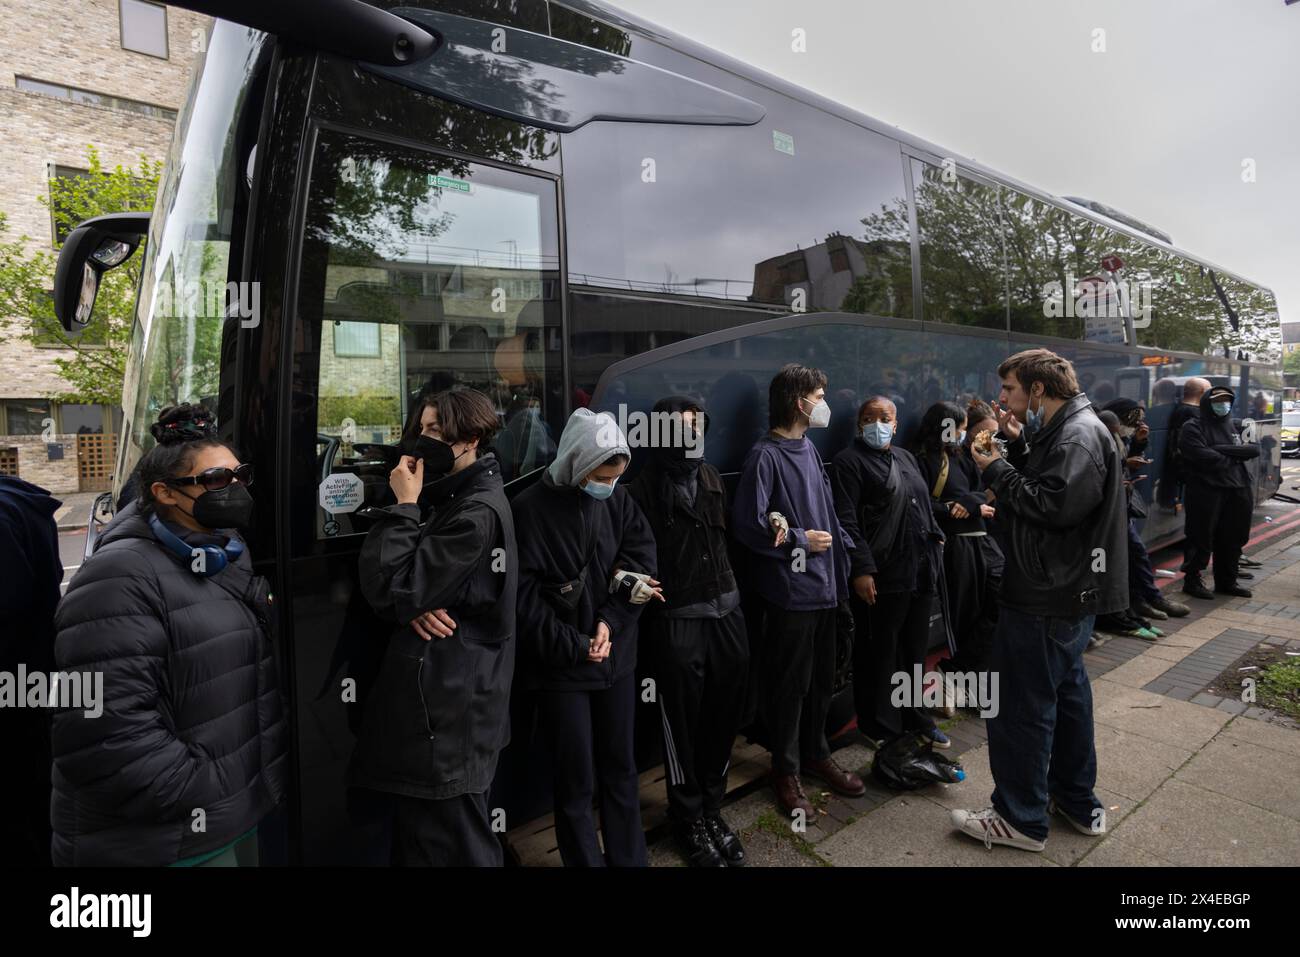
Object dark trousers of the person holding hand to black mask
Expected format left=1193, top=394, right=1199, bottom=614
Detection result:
left=391, top=792, right=502, bottom=867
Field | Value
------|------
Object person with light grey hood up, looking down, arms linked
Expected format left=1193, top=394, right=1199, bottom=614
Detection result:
left=514, top=408, right=663, bottom=867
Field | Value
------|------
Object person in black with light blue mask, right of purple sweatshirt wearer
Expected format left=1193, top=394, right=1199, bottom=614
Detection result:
left=831, top=395, right=950, bottom=748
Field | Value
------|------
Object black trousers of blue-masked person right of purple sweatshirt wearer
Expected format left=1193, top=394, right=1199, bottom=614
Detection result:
left=853, top=592, right=935, bottom=736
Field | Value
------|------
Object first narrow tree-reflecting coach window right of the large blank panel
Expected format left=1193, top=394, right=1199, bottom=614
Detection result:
left=913, top=160, right=1006, bottom=329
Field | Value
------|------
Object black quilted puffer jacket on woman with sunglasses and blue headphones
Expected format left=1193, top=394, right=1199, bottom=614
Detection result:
left=52, top=503, right=287, bottom=866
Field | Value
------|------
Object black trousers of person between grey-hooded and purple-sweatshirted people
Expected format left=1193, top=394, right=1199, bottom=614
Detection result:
left=642, top=609, right=749, bottom=822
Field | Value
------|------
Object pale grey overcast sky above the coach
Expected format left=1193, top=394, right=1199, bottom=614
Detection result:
left=611, top=0, right=1300, bottom=321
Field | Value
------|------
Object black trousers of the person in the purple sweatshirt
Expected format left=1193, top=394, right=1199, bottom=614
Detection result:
left=761, top=605, right=836, bottom=774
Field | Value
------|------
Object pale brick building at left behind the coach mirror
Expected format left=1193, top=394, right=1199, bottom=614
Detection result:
left=0, top=0, right=209, bottom=495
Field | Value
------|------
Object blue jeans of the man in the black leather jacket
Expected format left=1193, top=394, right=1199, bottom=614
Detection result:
left=988, top=605, right=1102, bottom=840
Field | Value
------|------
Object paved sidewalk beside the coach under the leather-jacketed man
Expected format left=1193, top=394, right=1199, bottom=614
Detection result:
left=650, top=509, right=1300, bottom=867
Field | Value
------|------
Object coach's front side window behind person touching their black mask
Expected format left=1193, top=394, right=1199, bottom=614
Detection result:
left=295, top=133, right=562, bottom=537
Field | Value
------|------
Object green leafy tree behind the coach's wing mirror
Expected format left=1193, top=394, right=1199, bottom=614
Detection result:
left=0, top=146, right=163, bottom=406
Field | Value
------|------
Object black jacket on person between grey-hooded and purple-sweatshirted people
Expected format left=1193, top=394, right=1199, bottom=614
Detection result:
left=628, top=460, right=736, bottom=609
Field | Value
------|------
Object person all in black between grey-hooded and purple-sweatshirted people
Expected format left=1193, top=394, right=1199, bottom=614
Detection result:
left=628, top=395, right=749, bottom=867
